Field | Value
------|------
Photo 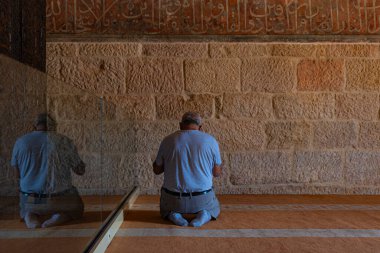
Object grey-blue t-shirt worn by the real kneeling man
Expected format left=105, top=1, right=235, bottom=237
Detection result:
left=156, top=130, right=222, bottom=192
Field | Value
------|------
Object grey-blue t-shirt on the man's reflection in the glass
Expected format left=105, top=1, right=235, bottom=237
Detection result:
left=11, top=131, right=81, bottom=194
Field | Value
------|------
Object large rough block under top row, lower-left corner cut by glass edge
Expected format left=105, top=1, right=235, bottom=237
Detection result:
left=57, top=57, right=125, bottom=94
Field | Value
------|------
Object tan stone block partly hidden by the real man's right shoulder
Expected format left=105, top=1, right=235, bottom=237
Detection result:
left=203, top=120, right=265, bottom=152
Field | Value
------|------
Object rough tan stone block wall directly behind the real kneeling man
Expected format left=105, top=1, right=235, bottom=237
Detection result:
left=47, top=42, right=380, bottom=194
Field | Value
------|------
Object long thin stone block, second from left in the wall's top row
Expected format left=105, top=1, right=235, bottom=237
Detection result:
left=77, top=42, right=141, bottom=57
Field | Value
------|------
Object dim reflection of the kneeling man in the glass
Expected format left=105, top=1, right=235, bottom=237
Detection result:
left=11, top=113, right=85, bottom=228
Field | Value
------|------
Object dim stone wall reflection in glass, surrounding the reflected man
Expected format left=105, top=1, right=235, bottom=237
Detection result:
left=0, top=54, right=111, bottom=196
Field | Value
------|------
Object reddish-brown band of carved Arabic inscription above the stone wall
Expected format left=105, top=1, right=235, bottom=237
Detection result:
left=47, top=0, right=380, bottom=35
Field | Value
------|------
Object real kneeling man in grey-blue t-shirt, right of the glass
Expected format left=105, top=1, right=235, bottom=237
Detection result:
left=153, top=112, right=222, bottom=227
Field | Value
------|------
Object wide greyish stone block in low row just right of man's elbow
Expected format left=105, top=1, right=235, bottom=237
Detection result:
left=230, top=152, right=292, bottom=185
